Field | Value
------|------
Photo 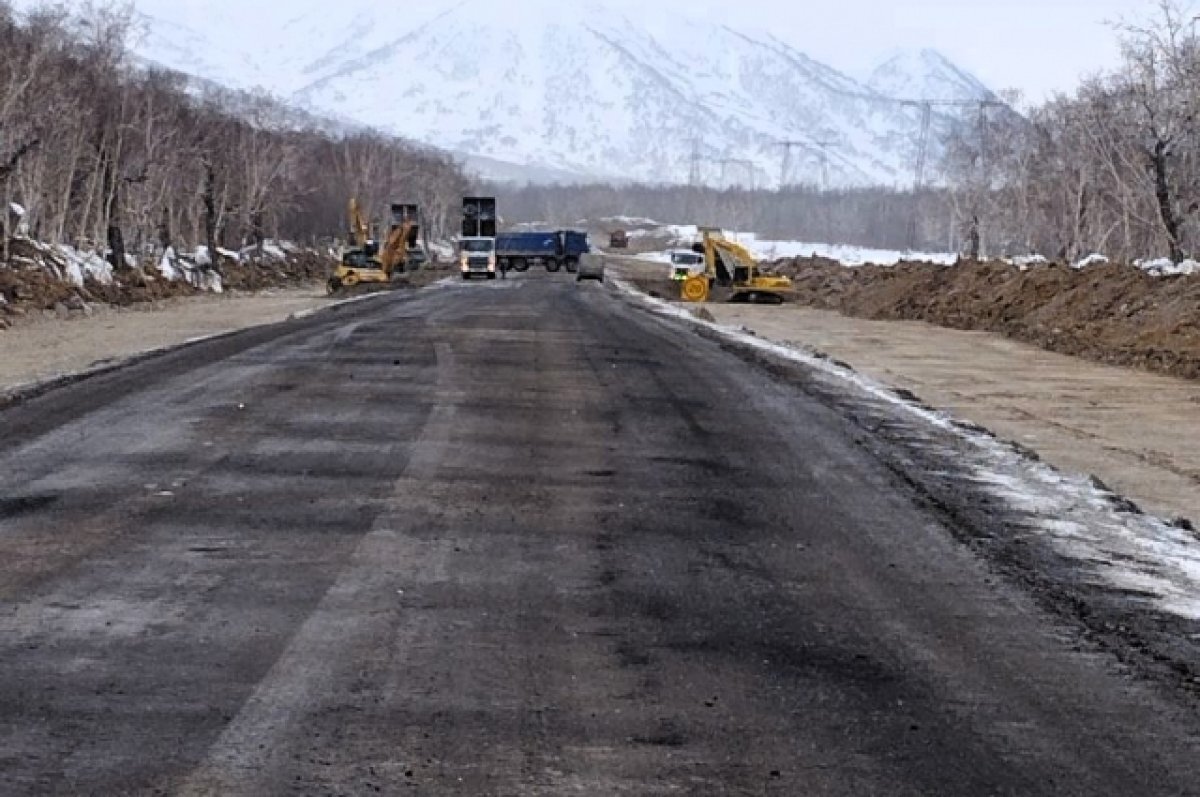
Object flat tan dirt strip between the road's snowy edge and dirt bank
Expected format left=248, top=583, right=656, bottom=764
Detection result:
left=706, top=304, right=1200, bottom=522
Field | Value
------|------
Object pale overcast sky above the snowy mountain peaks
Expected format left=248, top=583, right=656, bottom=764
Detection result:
left=121, top=0, right=1171, bottom=101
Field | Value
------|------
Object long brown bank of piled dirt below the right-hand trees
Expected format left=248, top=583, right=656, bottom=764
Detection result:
left=770, top=258, right=1200, bottom=379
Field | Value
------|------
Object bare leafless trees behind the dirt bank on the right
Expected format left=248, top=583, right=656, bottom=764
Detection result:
left=943, top=0, right=1200, bottom=262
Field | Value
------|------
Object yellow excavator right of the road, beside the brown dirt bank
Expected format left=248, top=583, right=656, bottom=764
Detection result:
left=680, top=227, right=792, bottom=305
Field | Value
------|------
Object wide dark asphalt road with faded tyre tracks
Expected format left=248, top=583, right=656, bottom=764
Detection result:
left=0, top=272, right=1200, bottom=797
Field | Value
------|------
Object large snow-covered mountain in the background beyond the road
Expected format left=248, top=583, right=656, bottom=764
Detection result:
left=114, top=0, right=990, bottom=186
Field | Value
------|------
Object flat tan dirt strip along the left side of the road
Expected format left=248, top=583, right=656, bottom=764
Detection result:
left=0, top=283, right=331, bottom=394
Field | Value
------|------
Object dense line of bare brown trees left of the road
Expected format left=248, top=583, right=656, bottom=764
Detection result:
left=0, top=0, right=467, bottom=268
